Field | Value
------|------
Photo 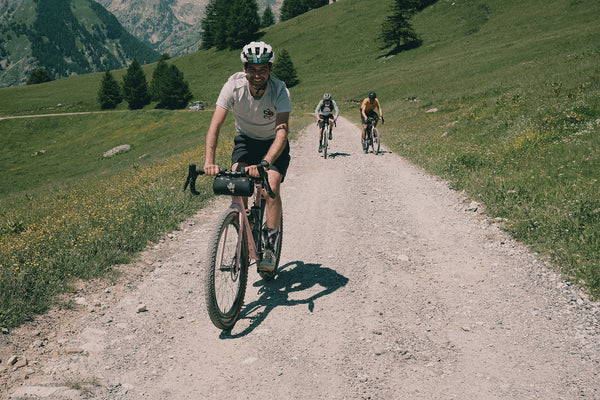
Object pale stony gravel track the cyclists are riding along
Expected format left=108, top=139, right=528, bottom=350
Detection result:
left=0, top=115, right=600, bottom=400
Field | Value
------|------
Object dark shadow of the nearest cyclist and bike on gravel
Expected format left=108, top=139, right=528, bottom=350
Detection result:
left=220, top=261, right=348, bottom=339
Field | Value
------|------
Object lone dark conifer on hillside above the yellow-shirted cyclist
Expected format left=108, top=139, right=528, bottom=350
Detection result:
left=380, top=0, right=422, bottom=54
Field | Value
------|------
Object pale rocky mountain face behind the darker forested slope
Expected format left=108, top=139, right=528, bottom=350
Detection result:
left=96, top=0, right=284, bottom=56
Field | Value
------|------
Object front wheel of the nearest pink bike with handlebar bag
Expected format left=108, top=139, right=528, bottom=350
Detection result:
left=204, top=208, right=249, bottom=330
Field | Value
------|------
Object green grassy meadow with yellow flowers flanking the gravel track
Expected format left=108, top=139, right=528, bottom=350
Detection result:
left=0, top=0, right=600, bottom=327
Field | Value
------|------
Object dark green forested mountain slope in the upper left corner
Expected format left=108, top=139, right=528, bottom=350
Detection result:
left=0, top=0, right=158, bottom=87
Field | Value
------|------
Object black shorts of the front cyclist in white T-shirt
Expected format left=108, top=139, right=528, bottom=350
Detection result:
left=231, top=135, right=290, bottom=182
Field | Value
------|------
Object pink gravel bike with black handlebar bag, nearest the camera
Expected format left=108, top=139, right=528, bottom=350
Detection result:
left=183, top=163, right=283, bottom=330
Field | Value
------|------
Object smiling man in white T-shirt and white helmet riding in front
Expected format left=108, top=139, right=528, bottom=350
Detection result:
left=204, top=42, right=292, bottom=271
